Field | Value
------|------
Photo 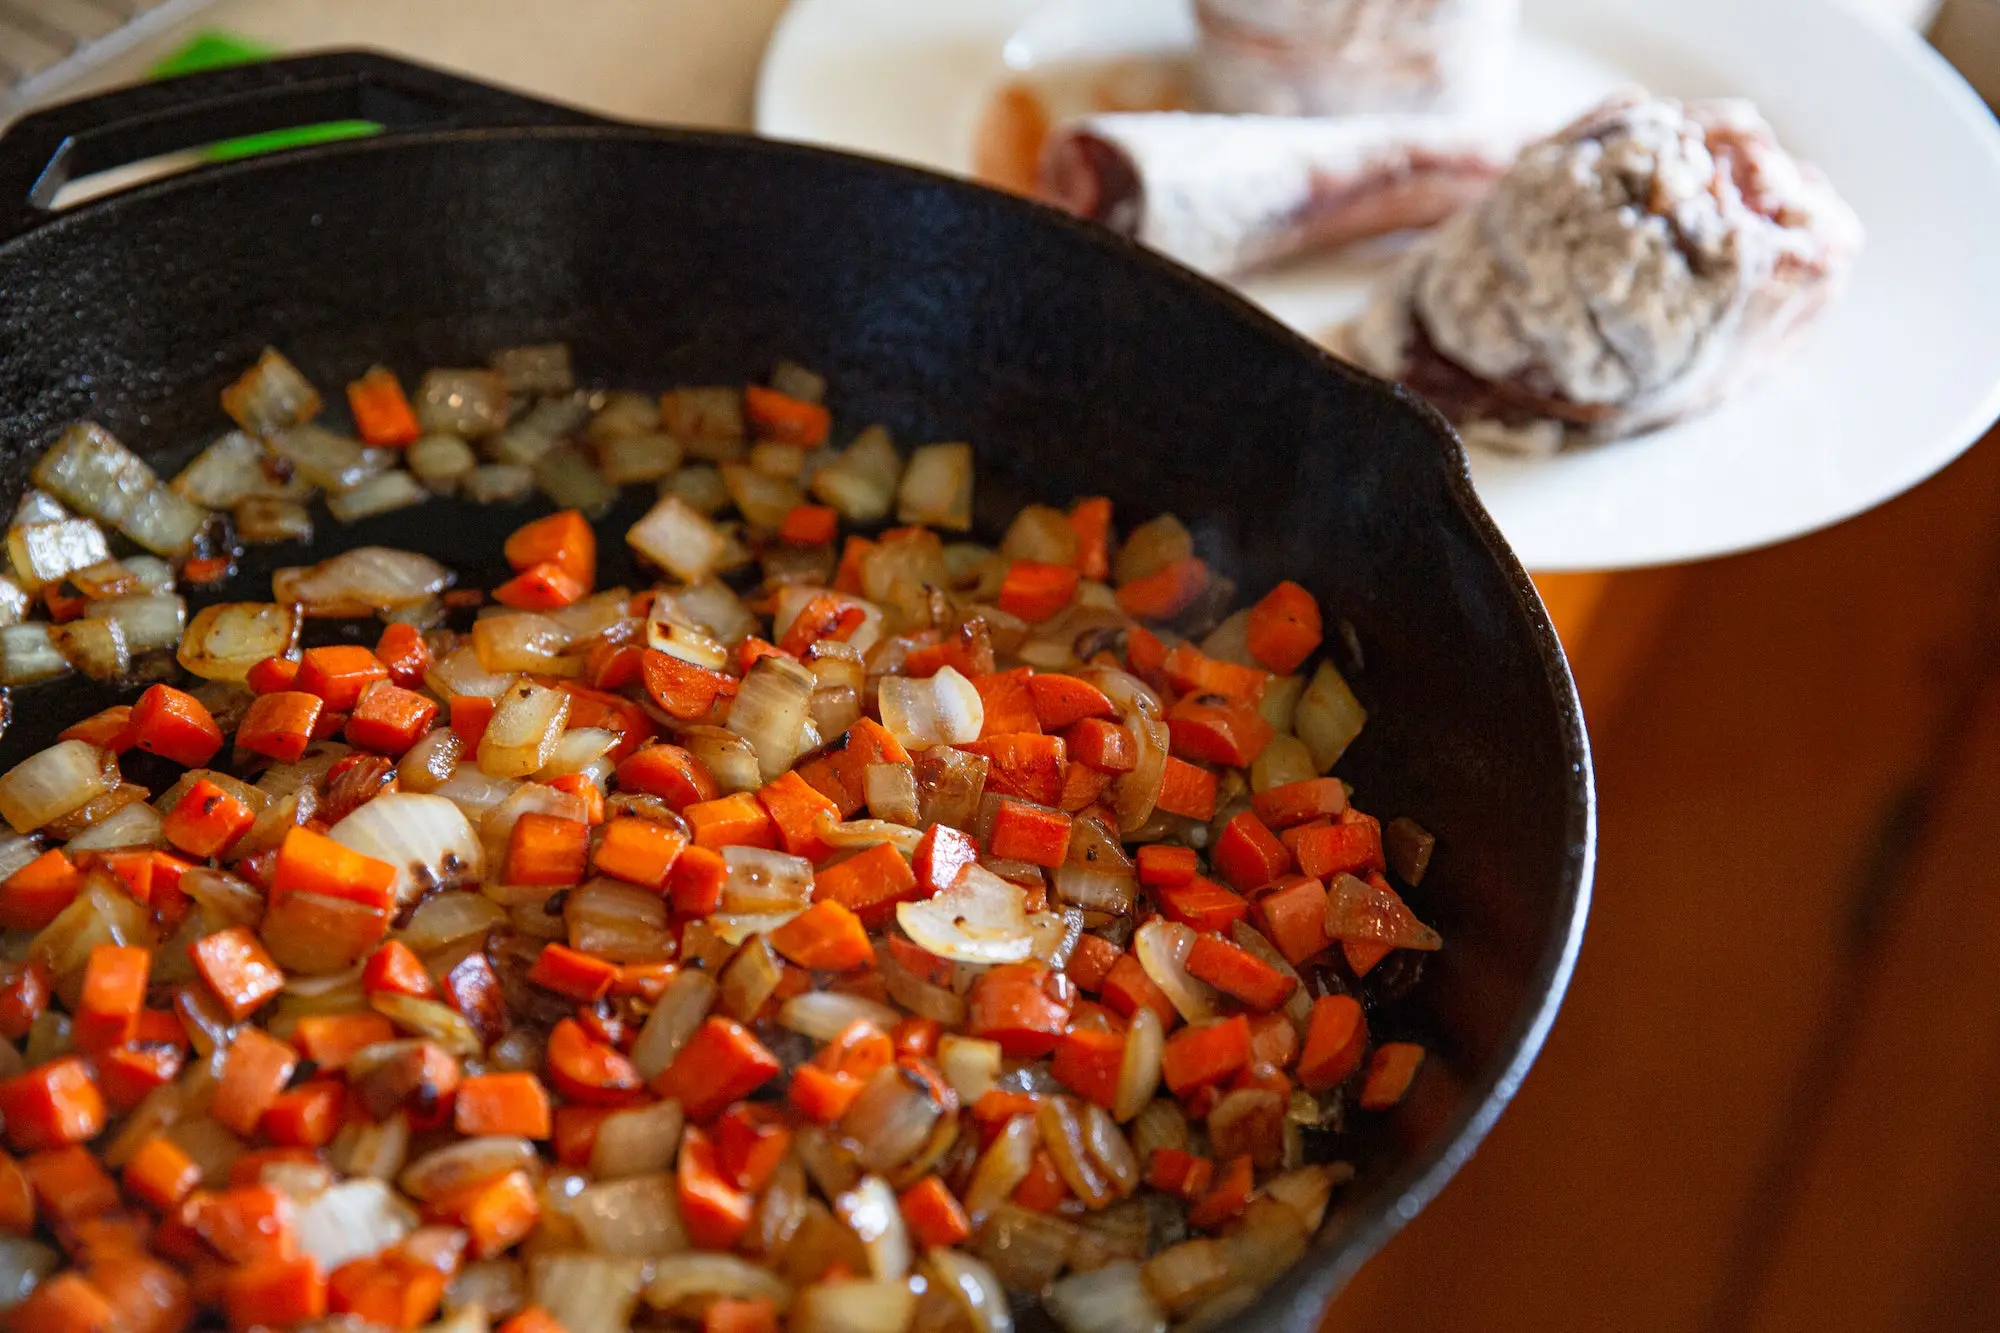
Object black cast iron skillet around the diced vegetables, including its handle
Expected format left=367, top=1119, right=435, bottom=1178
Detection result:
left=0, top=54, right=1594, bottom=1333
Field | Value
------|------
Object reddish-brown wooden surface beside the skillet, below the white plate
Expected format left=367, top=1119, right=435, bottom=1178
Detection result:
left=1326, top=428, right=2000, bottom=1333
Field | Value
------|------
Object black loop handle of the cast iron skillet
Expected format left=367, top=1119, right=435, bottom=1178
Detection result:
left=0, top=50, right=602, bottom=242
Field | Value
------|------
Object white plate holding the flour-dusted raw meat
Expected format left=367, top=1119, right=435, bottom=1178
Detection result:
left=756, top=0, right=2000, bottom=570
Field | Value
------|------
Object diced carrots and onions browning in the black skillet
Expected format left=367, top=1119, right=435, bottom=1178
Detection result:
left=0, top=346, right=1440, bottom=1333
